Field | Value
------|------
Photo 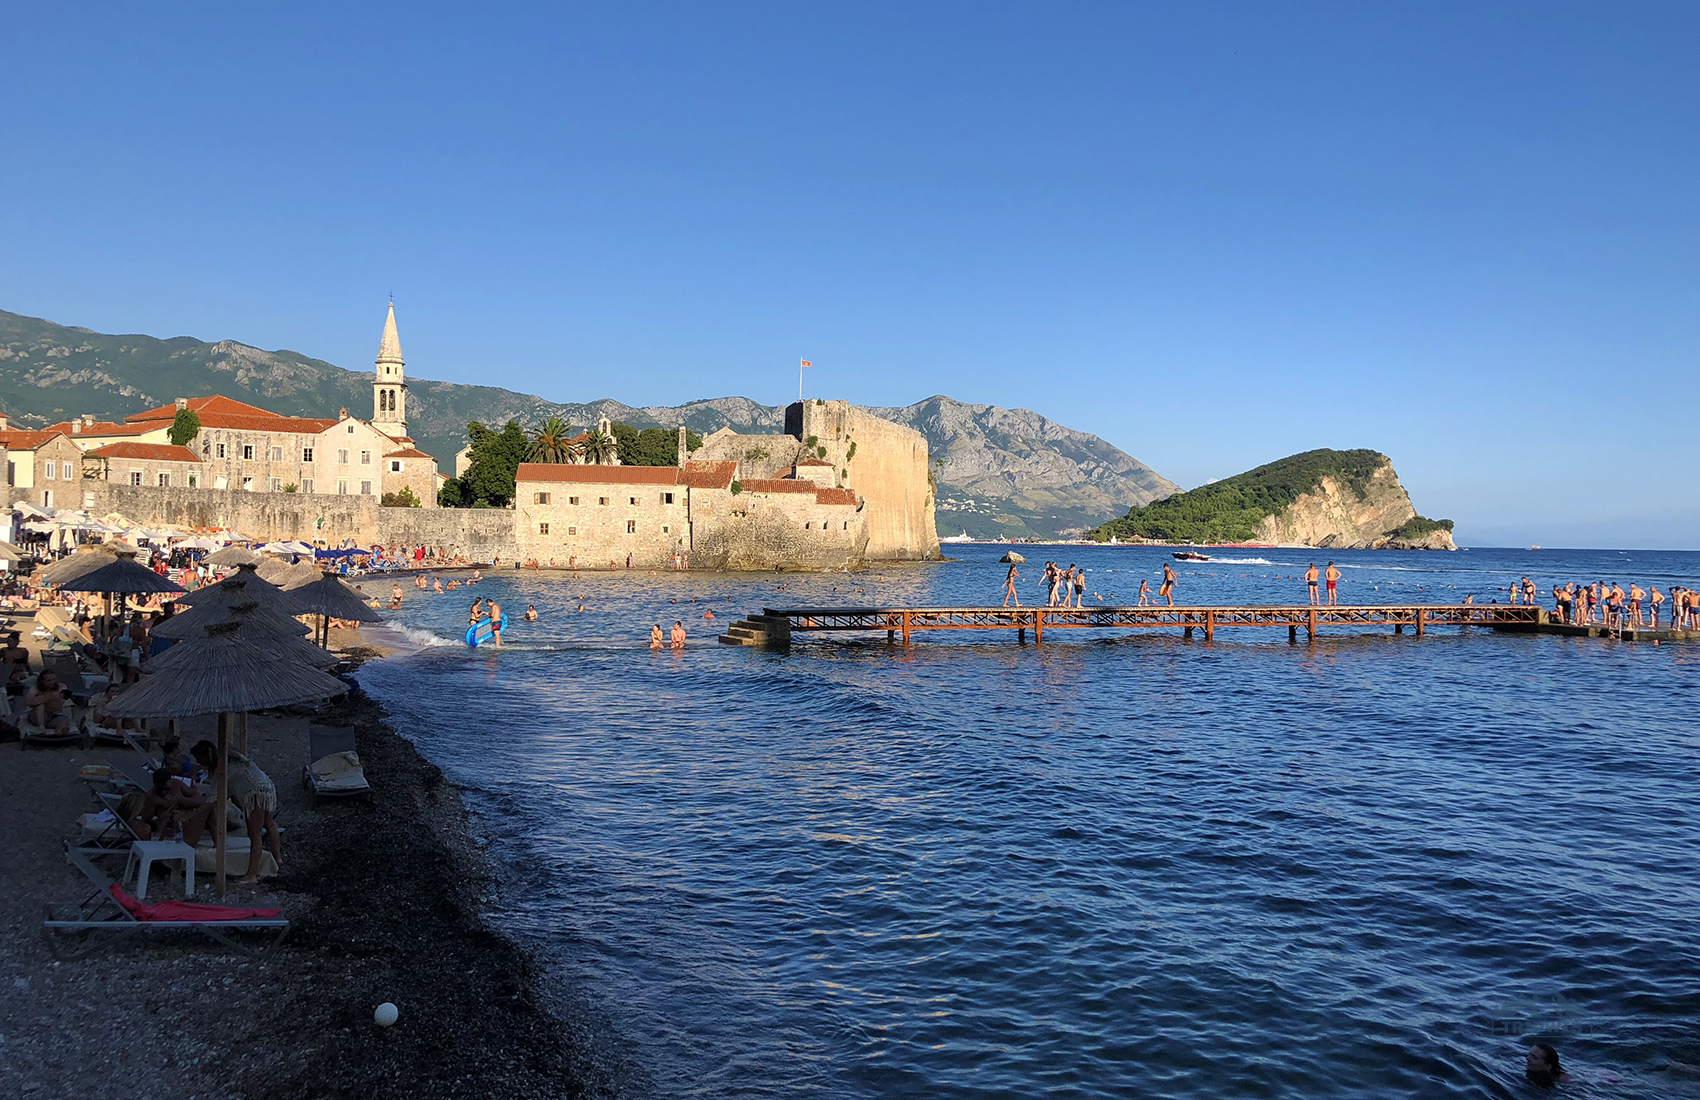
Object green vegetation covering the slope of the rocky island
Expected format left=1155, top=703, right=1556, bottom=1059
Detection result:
left=1091, top=447, right=1400, bottom=542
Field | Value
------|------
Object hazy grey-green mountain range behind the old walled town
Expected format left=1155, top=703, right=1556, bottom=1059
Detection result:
left=0, top=311, right=1178, bottom=537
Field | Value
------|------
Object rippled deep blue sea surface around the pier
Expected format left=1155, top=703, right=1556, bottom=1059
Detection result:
left=360, top=546, right=1700, bottom=1098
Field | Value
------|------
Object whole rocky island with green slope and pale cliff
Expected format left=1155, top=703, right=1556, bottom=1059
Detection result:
left=1093, top=447, right=1457, bottom=549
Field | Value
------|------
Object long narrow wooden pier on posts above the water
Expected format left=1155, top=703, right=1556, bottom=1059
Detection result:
left=721, top=604, right=1557, bottom=646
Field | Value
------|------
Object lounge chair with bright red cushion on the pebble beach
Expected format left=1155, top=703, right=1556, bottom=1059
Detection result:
left=43, top=847, right=289, bottom=959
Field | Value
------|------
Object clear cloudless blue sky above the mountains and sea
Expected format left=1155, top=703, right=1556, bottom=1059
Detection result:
left=0, top=2, right=1700, bottom=547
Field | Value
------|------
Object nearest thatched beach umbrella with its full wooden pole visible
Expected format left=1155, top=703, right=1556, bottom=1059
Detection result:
left=105, top=622, right=349, bottom=896
